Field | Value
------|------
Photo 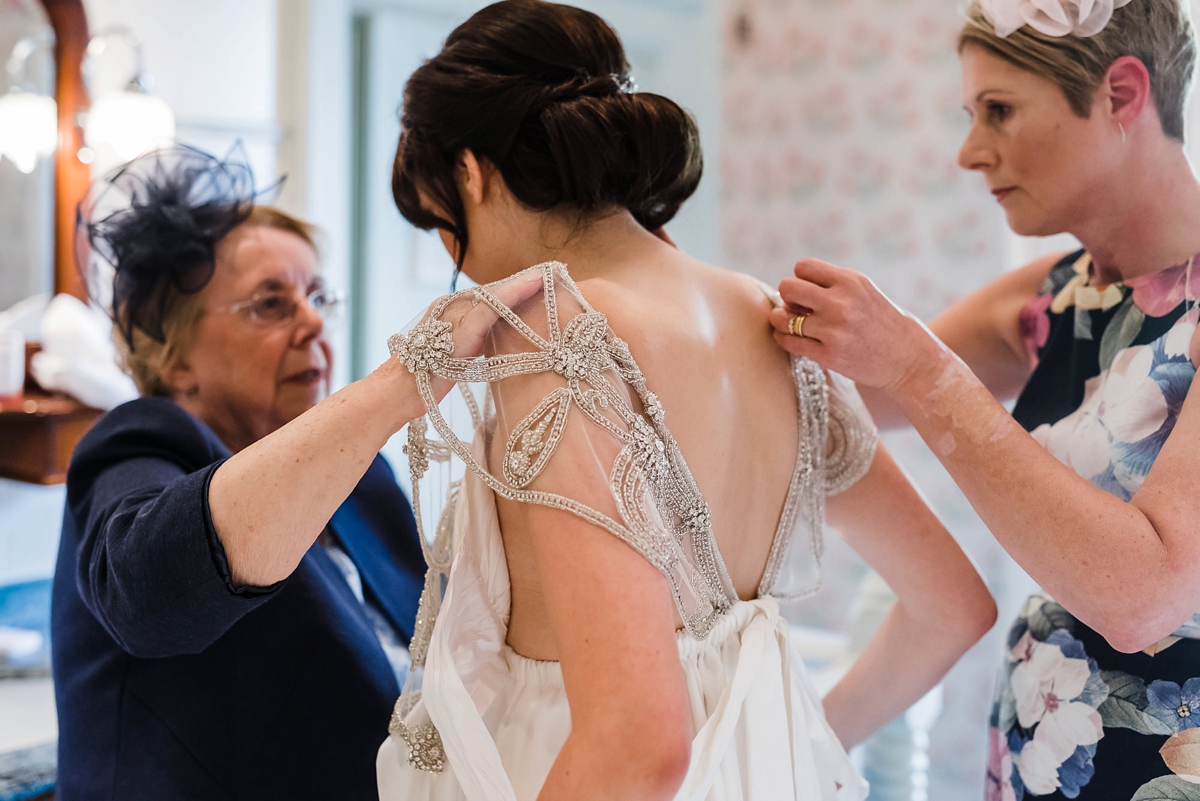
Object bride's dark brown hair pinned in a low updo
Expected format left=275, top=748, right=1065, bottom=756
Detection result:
left=391, top=0, right=703, bottom=266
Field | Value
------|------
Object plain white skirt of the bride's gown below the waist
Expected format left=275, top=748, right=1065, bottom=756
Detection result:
left=377, top=598, right=866, bottom=801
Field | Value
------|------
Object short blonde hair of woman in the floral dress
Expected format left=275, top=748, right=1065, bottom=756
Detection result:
left=959, top=0, right=1196, bottom=141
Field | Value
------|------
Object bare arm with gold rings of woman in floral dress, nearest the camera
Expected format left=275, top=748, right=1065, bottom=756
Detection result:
left=772, top=261, right=1200, bottom=652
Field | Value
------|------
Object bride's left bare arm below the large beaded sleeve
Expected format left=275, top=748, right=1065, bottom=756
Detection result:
left=518, top=507, right=692, bottom=801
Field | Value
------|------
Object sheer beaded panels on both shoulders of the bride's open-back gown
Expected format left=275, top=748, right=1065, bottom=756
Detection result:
left=390, top=263, right=876, bottom=662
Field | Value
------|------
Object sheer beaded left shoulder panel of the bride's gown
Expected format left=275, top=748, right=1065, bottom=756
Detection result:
left=389, top=261, right=733, bottom=652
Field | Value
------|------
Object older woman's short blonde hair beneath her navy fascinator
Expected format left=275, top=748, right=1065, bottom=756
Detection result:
left=113, top=206, right=319, bottom=398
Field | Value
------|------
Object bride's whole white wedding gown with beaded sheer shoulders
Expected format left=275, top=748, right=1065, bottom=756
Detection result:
left=377, top=263, right=876, bottom=801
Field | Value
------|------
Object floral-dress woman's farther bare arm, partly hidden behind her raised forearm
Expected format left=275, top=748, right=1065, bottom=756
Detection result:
left=859, top=253, right=1063, bottom=428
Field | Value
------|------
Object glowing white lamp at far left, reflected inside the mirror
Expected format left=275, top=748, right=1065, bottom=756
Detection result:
left=0, top=36, right=59, bottom=174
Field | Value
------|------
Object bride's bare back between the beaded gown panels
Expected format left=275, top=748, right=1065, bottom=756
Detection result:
left=498, top=248, right=798, bottom=660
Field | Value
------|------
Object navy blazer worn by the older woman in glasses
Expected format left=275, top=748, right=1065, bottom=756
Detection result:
left=52, top=398, right=425, bottom=801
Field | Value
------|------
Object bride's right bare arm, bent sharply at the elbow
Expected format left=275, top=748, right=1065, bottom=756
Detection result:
left=824, top=446, right=996, bottom=748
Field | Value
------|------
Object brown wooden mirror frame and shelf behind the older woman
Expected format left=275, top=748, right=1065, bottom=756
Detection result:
left=0, top=0, right=102, bottom=484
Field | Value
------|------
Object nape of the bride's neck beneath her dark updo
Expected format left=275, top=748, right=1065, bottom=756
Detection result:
left=464, top=203, right=667, bottom=283
